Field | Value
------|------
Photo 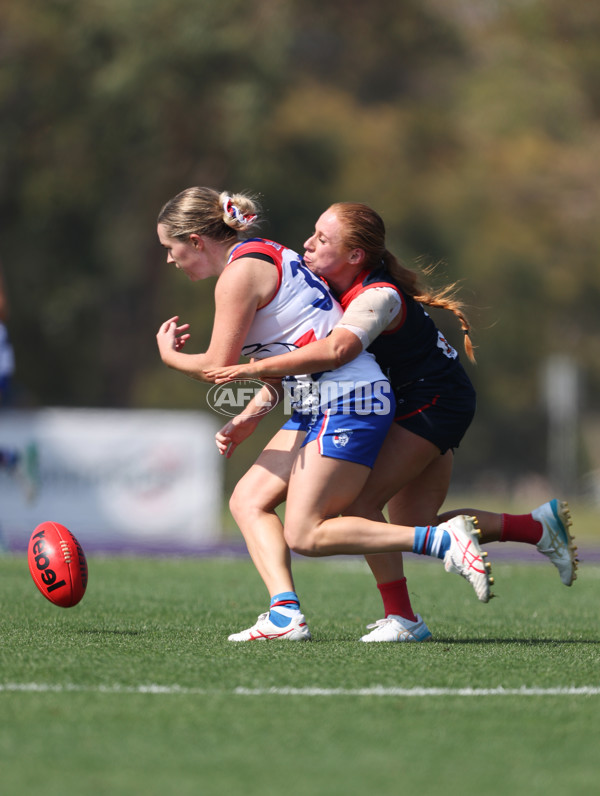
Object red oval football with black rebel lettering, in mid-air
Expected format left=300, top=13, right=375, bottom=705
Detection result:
left=27, top=522, right=87, bottom=608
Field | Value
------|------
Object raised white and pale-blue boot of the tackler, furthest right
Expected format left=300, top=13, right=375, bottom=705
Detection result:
left=531, top=498, right=579, bottom=586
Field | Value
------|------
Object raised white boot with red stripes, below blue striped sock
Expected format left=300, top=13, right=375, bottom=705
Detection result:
left=438, top=515, right=494, bottom=603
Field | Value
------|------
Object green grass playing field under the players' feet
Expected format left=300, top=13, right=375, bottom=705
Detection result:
left=0, top=548, right=600, bottom=796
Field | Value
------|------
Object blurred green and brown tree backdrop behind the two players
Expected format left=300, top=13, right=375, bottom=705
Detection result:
left=0, top=0, right=600, bottom=488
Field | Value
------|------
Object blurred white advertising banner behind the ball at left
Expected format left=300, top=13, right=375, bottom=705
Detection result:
left=0, top=409, right=223, bottom=553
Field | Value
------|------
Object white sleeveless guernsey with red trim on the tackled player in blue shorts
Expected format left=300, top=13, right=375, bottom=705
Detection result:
left=228, top=238, right=386, bottom=412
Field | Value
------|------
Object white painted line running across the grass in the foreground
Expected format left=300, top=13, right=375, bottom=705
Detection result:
left=0, top=683, right=600, bottom=697
